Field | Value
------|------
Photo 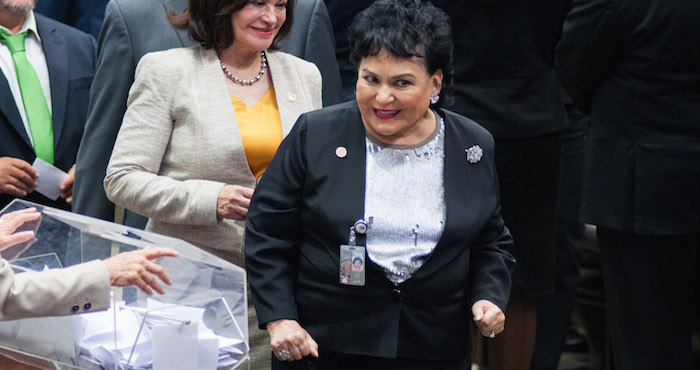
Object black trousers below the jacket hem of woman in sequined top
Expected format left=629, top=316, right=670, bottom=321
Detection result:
left=272, top=352, right=471, bottom=370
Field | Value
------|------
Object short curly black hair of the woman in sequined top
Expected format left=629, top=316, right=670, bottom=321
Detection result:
left=347, top=0, right=458, bottom=104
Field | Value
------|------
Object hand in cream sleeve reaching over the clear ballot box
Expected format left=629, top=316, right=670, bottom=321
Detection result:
left=102, top=248, right=179, bottom=295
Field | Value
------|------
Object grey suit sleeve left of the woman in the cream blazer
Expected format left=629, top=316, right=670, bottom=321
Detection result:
left=73, top=1, right=135, bottom=221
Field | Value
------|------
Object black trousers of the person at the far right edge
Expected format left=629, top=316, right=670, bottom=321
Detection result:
left=597, top=227, right=700, bottom=370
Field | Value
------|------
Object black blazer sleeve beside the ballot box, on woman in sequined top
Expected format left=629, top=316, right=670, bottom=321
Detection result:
left=245, top=115, right=306, bottom=328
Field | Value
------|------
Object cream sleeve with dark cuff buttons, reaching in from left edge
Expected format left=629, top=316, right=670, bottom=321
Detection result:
left=0, top=259, right=109, bottom=320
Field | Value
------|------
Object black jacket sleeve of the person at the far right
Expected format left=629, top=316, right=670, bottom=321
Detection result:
left=555, top=0, right=621, bottom=112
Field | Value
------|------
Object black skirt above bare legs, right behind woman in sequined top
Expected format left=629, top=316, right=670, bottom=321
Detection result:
left=496, top=132, right=564, bottom=300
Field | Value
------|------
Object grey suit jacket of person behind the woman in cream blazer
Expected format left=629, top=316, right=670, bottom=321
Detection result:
left=73, top=0, right=341, bottom=227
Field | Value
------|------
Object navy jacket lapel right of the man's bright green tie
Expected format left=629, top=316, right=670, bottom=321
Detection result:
left=36, top=16, right=69, bottom=148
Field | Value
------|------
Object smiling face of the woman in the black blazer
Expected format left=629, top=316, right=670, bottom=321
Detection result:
left=356, top=51, right=442, bottom=145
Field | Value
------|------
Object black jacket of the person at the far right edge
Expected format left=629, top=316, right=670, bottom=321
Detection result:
left=557, top=0, right=700, bottom=235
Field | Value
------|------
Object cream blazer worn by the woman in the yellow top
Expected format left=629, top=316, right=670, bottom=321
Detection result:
left=104, top=46, right=322, bottom=266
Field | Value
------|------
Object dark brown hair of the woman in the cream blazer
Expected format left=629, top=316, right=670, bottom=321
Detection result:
left=168, top=0, right=295, bottom=50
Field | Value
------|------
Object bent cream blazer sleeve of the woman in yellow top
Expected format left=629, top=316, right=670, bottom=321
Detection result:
left=104, top=53, right=225, bottom=226
